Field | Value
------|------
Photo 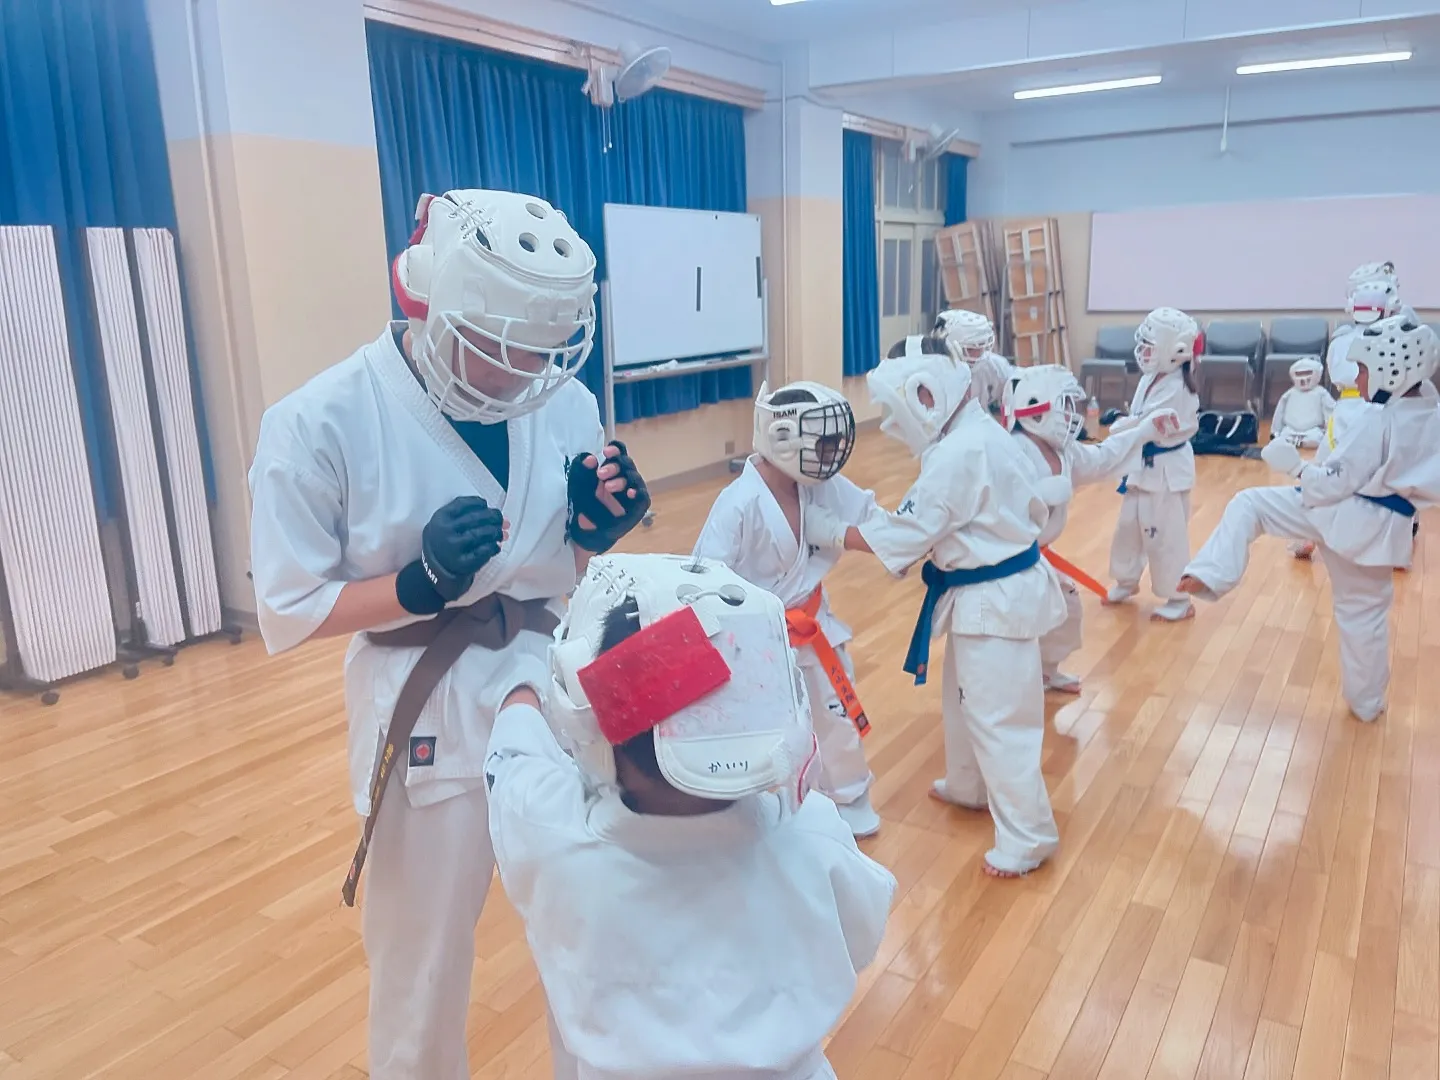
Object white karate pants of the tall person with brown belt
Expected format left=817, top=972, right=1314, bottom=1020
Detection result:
left=360, top=773, right=576, bottom=1080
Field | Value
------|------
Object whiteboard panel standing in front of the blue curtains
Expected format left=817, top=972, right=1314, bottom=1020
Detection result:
left=605, top=203, right=765, bottom=367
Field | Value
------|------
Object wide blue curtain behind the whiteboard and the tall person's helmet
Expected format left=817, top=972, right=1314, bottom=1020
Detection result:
left=366, top=22, right=752, bottom=423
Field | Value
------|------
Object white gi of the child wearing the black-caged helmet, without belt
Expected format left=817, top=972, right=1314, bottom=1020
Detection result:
left=694, top=458, right=877, bottom=805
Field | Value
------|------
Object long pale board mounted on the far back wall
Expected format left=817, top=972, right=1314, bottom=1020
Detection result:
left=1090, top=194, right=1440, bottom=312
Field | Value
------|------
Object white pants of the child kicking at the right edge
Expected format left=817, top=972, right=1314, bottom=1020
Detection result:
left=1185, top=487, right=1395, bottom=720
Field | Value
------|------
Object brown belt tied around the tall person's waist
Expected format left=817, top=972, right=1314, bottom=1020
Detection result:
left=340, top=593, right=560, bottom=907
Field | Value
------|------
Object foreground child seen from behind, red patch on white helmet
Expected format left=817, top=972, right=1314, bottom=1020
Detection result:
left=485, top=554, right=896, bottom=1080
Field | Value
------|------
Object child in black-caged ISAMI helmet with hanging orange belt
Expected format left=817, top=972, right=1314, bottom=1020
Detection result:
left=694, top=383, right=880, bottom=837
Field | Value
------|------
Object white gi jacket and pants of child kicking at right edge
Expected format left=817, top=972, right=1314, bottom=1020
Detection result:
left=1185, top=397, right=1440, bottom=720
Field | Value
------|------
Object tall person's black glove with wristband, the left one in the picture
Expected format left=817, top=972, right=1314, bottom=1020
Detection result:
left=395, top=495, right=504, bottom=615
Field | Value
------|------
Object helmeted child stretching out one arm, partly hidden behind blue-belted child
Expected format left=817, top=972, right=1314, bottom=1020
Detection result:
left=1004, top=364, right=1179, bottom=694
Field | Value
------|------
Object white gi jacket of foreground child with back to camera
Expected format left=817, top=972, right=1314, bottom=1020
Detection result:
left=485, top=706, right=896, bottom=1080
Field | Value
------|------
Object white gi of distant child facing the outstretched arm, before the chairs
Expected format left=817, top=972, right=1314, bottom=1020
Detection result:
left=1110, top=372, right=1200, bottom=600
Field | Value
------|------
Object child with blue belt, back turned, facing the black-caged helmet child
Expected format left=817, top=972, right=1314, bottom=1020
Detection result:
left=815, top=341, right=1066, bottom=877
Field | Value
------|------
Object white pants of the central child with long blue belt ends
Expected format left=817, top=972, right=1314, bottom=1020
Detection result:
left=942, top=634, right=1060, bottom=874
